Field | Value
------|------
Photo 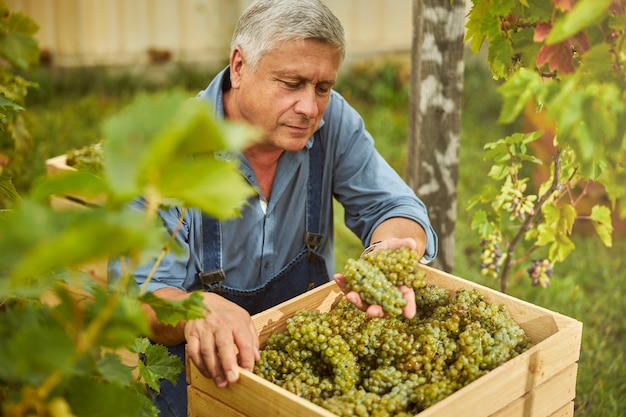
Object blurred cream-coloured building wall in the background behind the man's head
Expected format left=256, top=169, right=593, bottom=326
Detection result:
left=7, top=0, right=412, bottom=67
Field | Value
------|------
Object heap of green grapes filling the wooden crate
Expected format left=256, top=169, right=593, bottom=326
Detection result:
left=254, top=251, right=531, bottom=417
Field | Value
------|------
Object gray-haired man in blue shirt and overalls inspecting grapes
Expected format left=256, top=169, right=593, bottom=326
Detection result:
left=111, top=0, right=437, bottom=416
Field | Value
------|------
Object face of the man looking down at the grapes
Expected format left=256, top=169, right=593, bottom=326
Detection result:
left=225, top=39, right=341, bottom=151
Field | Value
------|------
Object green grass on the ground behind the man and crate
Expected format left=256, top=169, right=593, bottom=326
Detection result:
left=15, top=56, right=626, bottom=417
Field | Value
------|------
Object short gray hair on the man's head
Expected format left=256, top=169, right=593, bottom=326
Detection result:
left=230, top=0, right=346, bottom=69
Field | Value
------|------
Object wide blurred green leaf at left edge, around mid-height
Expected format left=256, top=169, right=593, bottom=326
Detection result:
left=0, top=199, right=166, bottom=285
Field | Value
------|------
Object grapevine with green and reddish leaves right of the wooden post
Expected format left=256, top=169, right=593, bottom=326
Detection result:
left=465, top=0, right=626, bottom=292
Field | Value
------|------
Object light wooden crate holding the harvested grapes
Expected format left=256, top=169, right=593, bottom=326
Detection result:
left=187, top=266, right=582, bottom=417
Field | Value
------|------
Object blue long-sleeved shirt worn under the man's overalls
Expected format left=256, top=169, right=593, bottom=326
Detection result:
left=119, top=68, right=437, bottom=291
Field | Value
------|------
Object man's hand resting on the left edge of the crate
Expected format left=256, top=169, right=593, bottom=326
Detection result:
left=185, top=292, right=260, bottom=388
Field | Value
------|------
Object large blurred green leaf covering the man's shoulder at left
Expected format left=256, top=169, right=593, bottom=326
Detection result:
left=103, top=91, right=258, bottom=210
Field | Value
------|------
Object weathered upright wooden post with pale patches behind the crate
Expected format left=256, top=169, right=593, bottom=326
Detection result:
left=406, top=0, right=466, bottom=272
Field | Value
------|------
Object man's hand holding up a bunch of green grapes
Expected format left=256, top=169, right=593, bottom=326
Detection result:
left=333, top=238, right=417, bottom=319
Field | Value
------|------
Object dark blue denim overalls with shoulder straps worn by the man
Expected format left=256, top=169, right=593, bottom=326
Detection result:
left=155, top=137, right=330, bottom=417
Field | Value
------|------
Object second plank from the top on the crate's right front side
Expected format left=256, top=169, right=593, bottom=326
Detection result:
left=490, top=363, right=578, bottom=417
